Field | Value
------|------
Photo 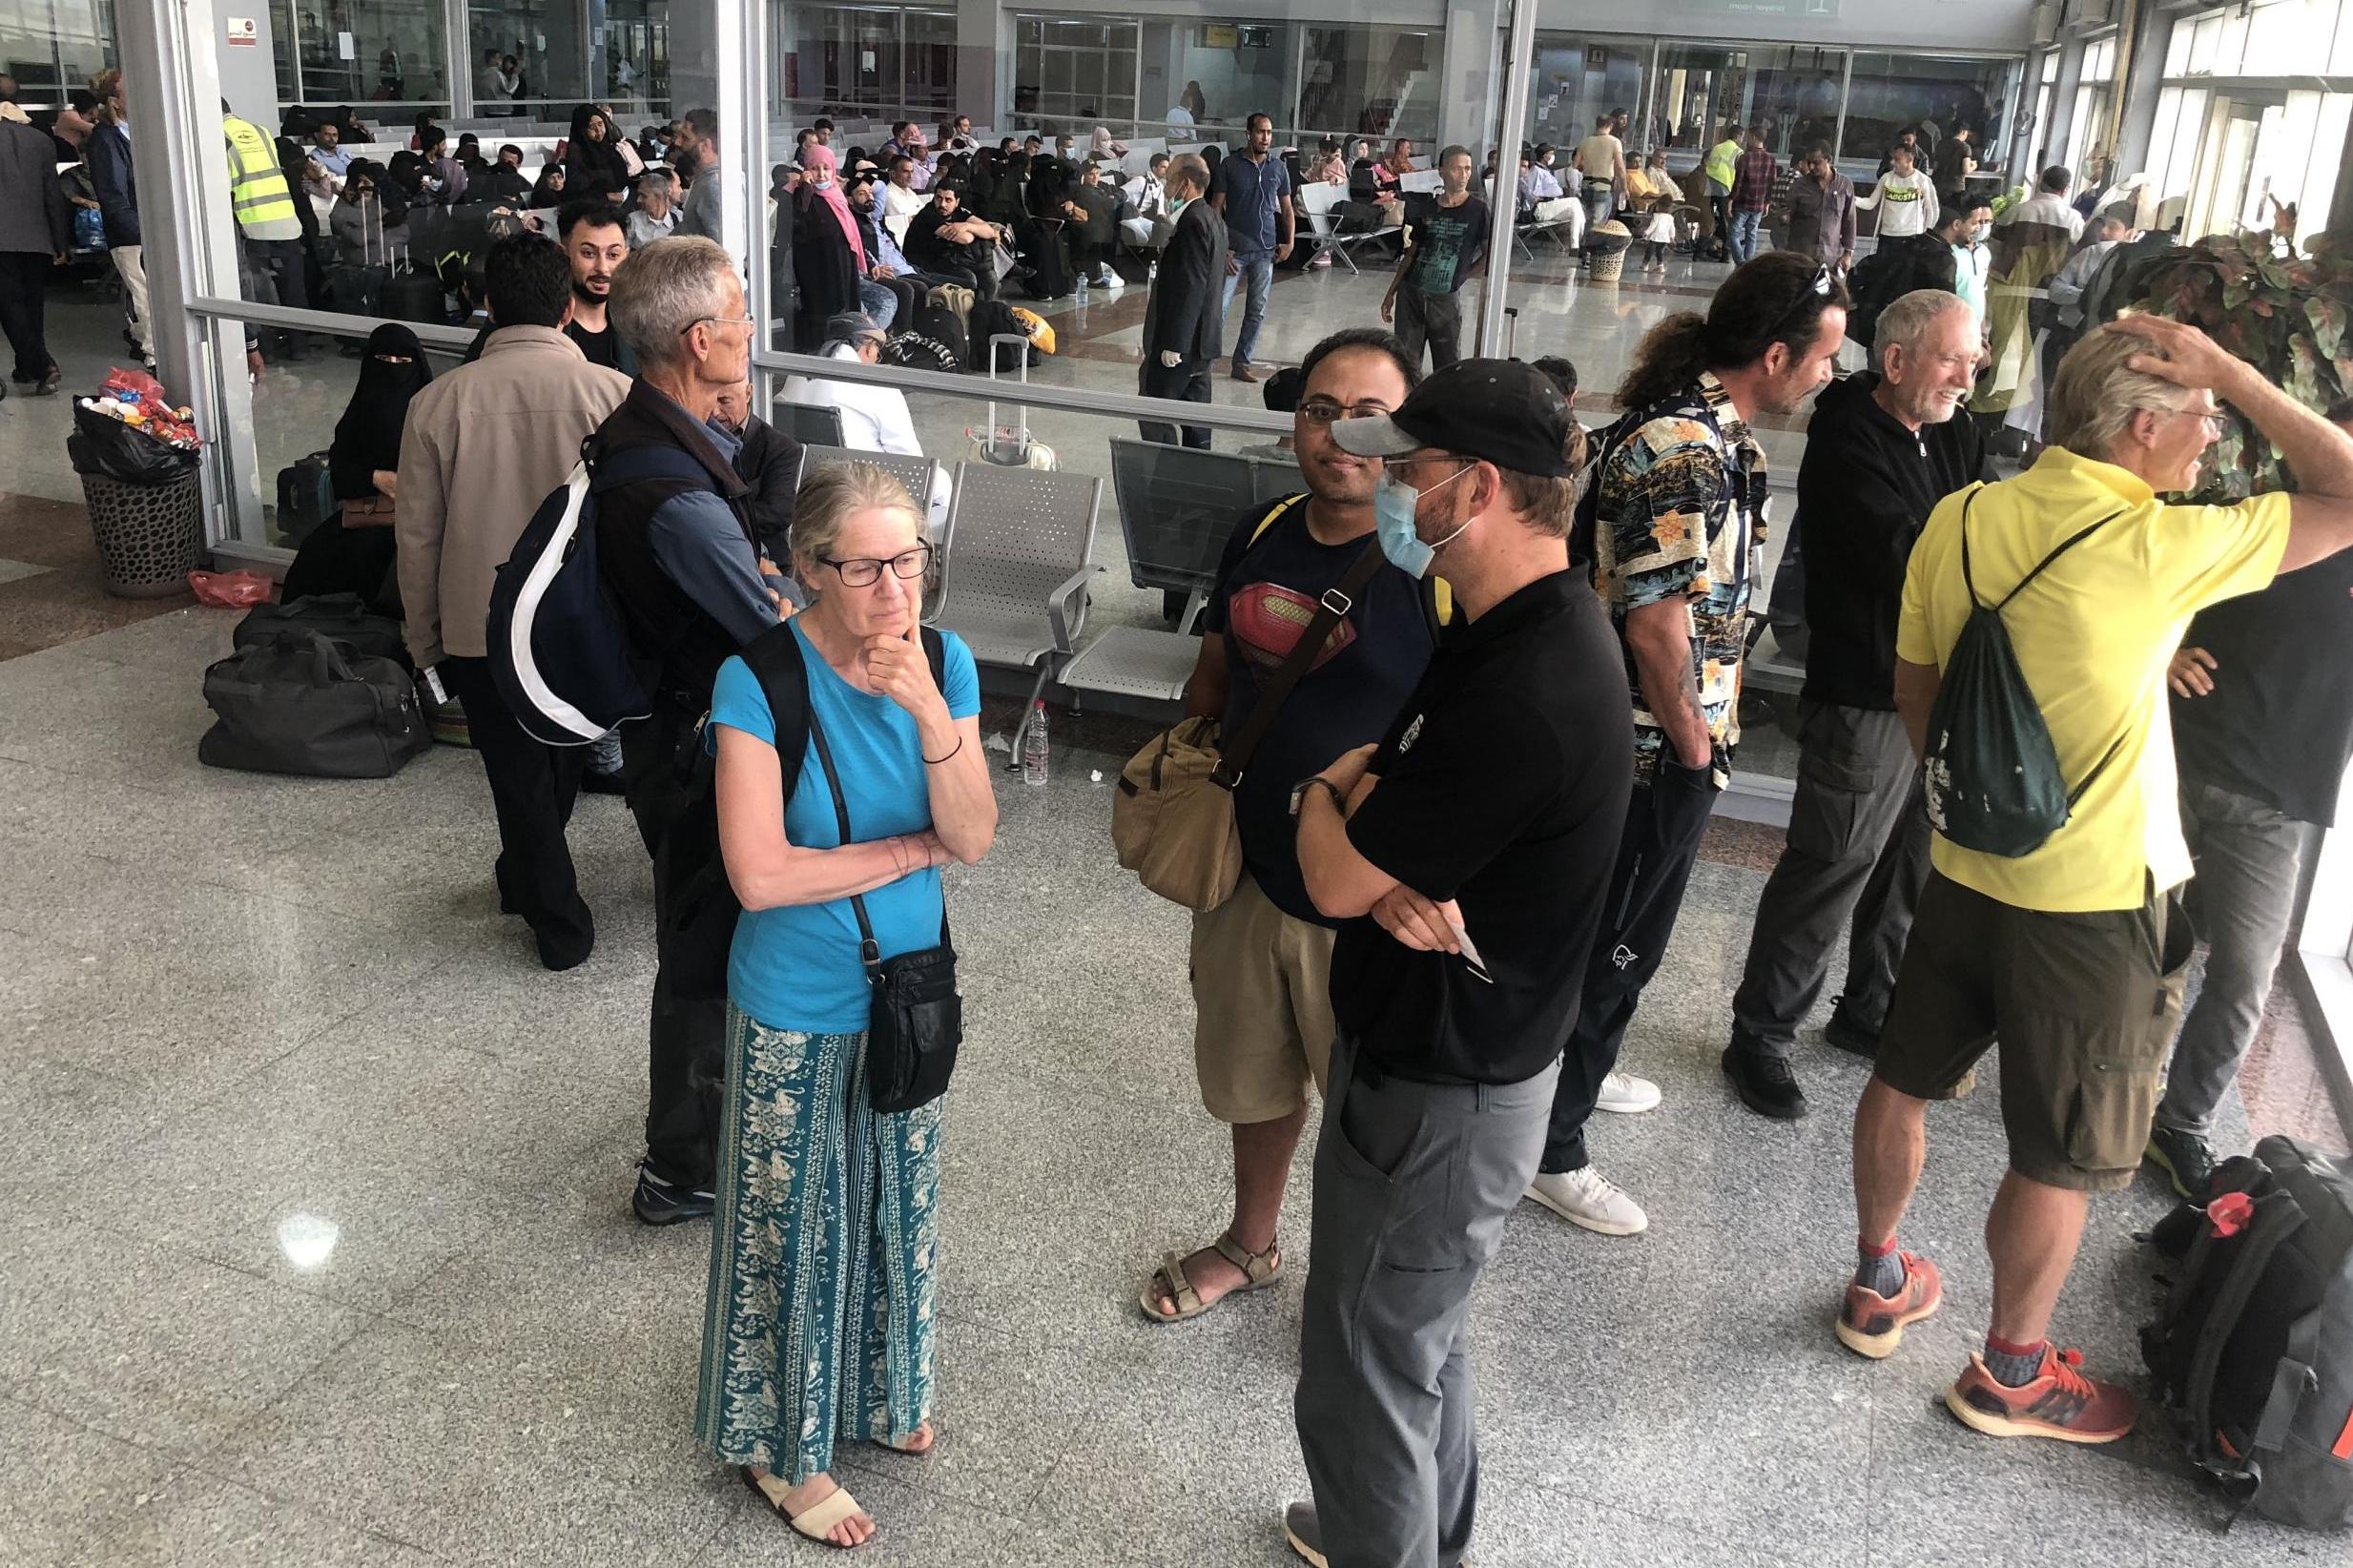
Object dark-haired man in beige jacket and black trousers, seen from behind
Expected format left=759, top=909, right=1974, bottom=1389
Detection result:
left=393, top=236, right=629, bottom=970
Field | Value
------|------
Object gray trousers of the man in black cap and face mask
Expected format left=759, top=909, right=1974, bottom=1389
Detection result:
left=1291, top=1036, right=1560, bottom=1568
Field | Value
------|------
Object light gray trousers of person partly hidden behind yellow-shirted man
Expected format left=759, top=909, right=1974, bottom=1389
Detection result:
left=2157, top=779, right=2316, bottom=1137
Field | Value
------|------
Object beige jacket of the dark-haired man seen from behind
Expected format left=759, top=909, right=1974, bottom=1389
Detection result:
left=393, top=327, right=629, bottom=669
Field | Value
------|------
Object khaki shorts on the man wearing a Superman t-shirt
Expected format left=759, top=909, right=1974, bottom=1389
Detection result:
left=1193, top=871, right=1339, bottom=1123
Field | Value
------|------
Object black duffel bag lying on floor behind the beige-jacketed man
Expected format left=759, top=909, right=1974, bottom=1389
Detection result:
left=196, top=631, right=433, bottom=779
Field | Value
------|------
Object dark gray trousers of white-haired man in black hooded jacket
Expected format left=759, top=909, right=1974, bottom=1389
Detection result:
left=1732, top=702, right=1930, bottom=1057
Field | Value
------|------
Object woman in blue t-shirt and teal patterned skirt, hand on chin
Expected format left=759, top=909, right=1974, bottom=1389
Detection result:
left=694, top=464, right=998, bottom=1547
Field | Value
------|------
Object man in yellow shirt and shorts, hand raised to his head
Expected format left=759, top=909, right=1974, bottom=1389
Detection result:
left=1838, top=316, right=2353, bottom=1443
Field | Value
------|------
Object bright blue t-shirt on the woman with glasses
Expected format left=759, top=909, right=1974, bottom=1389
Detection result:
left=711, top=622, right=981, bottom=1034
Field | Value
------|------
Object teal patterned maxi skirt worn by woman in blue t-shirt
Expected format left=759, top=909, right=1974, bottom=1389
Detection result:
left=694, top=1005, right=941, bottom=1486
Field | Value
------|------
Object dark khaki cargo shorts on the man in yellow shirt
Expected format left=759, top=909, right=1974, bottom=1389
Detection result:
left=1878, top=874, right=2196, bottom=1191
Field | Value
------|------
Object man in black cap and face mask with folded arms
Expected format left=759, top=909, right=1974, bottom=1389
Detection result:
left=1285, top=361, right=1633, bottom=1568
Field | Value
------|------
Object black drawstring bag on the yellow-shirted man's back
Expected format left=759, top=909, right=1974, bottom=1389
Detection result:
left=1925, top=485, right=2125, bottom=859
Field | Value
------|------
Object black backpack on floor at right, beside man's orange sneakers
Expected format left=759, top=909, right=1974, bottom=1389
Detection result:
left=2141, top=1137, right=2353, bottom=1531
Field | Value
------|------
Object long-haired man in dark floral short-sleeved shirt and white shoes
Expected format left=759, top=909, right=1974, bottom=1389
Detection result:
left=1527, top=252, right=1847, bottom=1236
